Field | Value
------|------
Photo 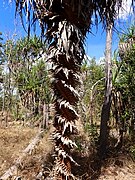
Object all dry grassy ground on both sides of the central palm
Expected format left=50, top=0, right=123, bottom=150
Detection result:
left=0, top=119, right=135, bottom=180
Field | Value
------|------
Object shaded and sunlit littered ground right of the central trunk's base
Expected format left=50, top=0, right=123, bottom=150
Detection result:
left=72, top=135, right=135, bottom=180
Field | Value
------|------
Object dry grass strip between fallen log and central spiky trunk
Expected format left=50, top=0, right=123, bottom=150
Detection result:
left=19, top=128, right=53, bottom=180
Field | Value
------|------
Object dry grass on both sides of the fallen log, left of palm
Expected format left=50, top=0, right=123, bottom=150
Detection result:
left=0, top=126, right=52, bottom=180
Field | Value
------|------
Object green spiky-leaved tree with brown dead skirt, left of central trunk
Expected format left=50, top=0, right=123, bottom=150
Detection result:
left=4, top=36, right=51, bottom=125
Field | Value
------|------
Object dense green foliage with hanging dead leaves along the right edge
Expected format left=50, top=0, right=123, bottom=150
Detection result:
left=113, top=23, right=135, bottom=134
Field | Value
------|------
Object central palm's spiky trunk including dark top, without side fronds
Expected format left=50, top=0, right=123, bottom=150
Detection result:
left=30, top=0, right=90, bottom=180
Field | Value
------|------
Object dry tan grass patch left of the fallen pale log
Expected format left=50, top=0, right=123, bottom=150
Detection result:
left=0, top=127, right=37, bottom=174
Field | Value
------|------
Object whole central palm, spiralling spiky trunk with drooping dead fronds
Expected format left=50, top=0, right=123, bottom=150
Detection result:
left=16, top=0, right=134, bottom=179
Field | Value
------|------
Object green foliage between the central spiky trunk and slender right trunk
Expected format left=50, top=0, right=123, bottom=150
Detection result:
left=82, top=58, right=105, bottom=122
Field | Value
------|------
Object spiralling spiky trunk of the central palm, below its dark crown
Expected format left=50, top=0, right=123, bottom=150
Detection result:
left=49, top=20, right=84, bottom=179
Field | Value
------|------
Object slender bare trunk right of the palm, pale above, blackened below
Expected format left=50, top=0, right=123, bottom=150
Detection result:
left=99, top=25, right=112, bottom=158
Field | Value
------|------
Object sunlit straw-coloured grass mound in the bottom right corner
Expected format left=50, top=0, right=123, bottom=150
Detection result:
left=98, top=154, right=135, bottom=180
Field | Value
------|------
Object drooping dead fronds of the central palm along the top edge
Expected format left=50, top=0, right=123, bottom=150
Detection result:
left=15, top=0, right=134, bottom=36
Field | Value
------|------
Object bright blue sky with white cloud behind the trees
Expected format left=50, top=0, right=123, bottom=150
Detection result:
left=0, top=0, right=132, bottom=61
